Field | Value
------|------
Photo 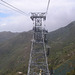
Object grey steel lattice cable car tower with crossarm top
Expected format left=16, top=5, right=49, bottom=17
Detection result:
left=27, top=13, right=49, bottom=75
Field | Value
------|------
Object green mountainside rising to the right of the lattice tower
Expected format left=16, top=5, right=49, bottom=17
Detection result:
left=48, top=21, right=75, bottom=75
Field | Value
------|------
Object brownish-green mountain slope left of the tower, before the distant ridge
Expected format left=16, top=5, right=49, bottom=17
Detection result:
left=0, top=32, right=32, bottom=75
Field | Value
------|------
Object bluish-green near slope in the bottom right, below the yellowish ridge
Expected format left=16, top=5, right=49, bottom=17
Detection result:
left=54, top=55, right=75, bottom=75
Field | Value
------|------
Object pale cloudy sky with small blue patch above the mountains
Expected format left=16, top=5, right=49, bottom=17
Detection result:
left=0, top=0, right=75, bottom=32
